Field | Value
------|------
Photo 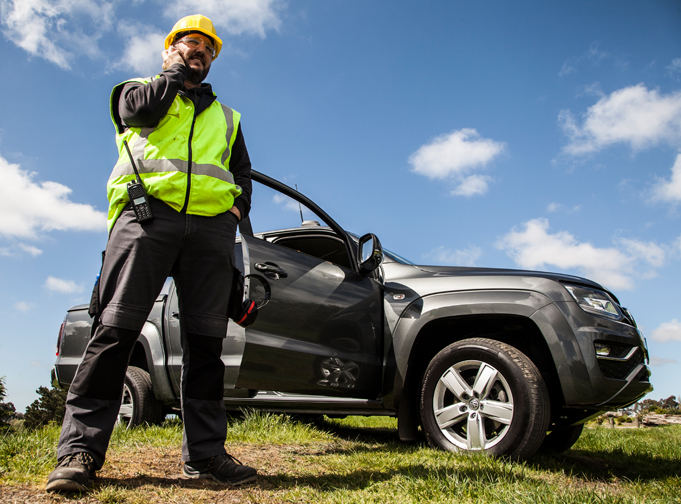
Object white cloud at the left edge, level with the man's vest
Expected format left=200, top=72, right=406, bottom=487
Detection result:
left=0, top=156, right=106, bottom=238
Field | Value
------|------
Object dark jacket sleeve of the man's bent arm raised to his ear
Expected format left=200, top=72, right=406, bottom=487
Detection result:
left=118, top=64, right=187, bottom=129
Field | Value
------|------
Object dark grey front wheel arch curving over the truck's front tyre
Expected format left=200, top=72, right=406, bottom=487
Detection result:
left=388, top=291, right=565, bottom=440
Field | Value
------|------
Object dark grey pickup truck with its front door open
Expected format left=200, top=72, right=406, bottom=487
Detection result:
left=52, top=171, right=652, bottom=458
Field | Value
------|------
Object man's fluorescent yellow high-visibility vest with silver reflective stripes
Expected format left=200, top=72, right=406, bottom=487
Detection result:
left=107, top=78, right=241, bottom=231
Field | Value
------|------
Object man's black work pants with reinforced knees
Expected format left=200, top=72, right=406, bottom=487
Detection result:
left=57, top=198, right=237, bottom=467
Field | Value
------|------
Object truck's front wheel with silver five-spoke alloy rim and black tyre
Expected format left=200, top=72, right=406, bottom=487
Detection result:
left=419, top=338, right=550, bottom=459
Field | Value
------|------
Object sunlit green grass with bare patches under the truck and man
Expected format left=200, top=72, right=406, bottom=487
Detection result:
left=0, top=413, right=681, bottom=504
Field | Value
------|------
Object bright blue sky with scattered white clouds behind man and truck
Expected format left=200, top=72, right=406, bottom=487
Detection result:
left=0, top=0, right=681, bottom=411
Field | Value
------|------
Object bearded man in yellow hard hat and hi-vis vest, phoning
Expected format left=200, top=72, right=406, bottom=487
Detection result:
left=47, top=14, right=257, bottom=491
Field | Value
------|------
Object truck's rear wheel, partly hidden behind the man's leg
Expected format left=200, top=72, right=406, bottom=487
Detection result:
left=116, top=366, right=165, bottom=429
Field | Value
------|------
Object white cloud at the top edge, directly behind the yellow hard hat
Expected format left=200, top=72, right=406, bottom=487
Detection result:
left=166, top=0, right=286, bottom=41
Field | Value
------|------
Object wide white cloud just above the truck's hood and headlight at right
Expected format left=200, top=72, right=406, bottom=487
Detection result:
left=496, top=219, right=666, bottom=289
